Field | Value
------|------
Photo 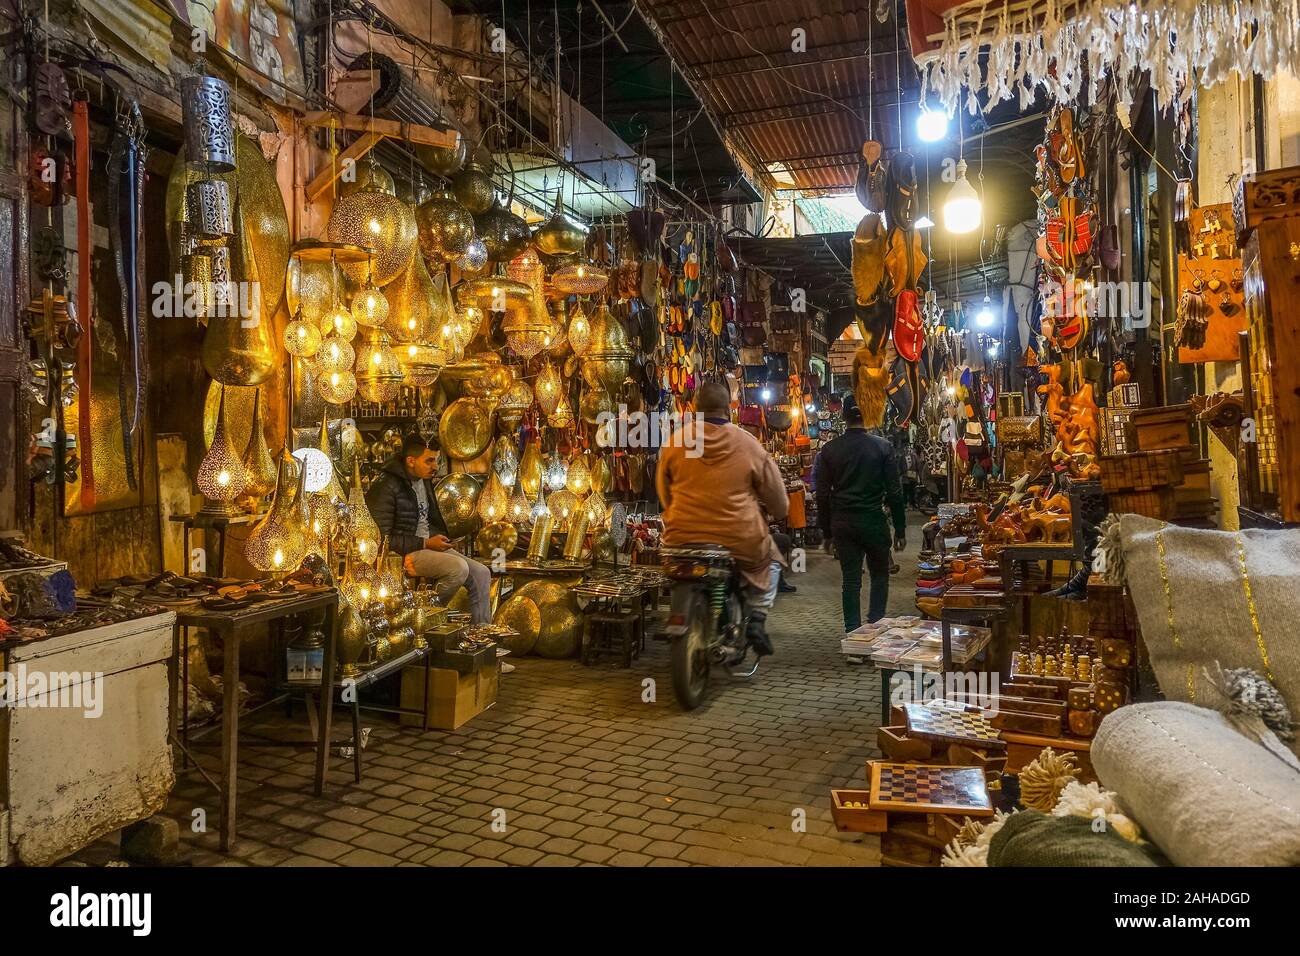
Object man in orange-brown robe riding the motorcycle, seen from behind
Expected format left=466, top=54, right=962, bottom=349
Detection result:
left=655, top=382, right=789, bottom=657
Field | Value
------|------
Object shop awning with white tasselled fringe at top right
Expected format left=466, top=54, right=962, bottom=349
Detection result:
left=906, top=0, right=1300, bottom=113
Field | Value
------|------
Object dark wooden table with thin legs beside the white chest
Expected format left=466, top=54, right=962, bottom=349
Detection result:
left=168, top=589, right=338, bottom=852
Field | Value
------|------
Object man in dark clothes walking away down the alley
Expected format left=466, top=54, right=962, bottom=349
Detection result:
left=813, top=406, right=907, bottom=631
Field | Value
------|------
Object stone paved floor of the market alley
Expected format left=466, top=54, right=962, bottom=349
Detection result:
left=149, top=527, right=920, bottom=866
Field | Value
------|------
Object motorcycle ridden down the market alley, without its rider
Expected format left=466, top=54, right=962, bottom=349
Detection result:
left=662, top=544, right=758, bottom=710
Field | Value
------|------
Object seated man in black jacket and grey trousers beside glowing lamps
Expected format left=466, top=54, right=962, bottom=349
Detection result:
left=365, top=434, right=491, bottom=624
